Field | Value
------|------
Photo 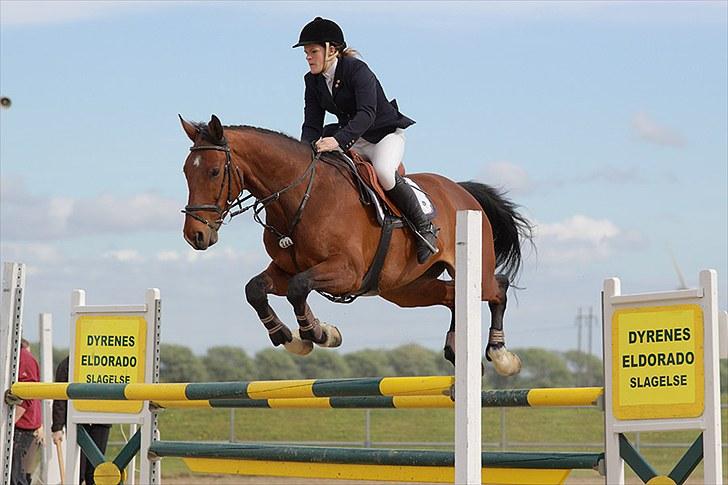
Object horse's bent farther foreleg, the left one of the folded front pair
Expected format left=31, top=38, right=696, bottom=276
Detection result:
left=245, top=263, right=311, bottom=355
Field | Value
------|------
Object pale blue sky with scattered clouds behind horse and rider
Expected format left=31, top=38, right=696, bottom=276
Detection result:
left=0, top=0, right=728, bottom=364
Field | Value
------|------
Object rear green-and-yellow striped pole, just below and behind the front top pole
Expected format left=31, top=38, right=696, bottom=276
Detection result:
left=153, top=387, right=604, bottom=409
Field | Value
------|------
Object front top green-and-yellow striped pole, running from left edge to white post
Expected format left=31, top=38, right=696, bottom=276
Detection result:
left=11, top=376, right=455, bottom=401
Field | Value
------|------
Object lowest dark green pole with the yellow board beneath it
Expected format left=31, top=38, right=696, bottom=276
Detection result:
left=149, top=441, right=603, bottom=485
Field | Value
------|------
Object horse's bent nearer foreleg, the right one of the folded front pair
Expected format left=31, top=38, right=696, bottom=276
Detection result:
left=286, top=260, right=356, bottom=347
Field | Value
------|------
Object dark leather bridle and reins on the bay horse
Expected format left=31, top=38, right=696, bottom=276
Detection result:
left=182, top=140, right=320, bottom=249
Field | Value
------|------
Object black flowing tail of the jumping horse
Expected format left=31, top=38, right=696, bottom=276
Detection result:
left=458, top=182, right=533, bottom=281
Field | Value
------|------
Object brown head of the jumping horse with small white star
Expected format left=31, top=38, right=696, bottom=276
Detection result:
left=180, top=115, right=243, bottom=250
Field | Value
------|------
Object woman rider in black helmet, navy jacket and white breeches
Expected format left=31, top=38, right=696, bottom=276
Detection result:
left=293, top=17, right=437, bottom=263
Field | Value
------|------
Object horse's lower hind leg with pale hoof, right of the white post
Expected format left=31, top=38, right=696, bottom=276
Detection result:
left=485, top=275, right=521, bottom=376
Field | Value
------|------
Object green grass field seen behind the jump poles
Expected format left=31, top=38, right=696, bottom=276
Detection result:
left=108, top=402, right=728, bottom=483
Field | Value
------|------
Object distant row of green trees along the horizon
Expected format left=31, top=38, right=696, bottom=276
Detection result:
left=37, top=344, right=728, bottom=393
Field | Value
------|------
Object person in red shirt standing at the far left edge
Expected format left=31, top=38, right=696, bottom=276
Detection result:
left=10, top=339, right=43, bottom=485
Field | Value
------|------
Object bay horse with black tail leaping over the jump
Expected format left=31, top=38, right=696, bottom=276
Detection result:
left=180, top=115, right=532, bottom=375
